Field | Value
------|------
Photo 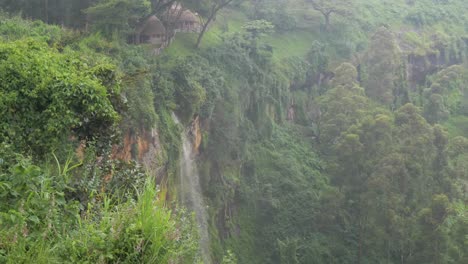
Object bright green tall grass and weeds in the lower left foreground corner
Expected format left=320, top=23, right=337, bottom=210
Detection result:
left=0, top=156, right=197, bottom=263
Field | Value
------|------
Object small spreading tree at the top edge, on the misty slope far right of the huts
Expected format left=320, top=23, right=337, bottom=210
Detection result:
left=308, top=0, right=351, bottom=31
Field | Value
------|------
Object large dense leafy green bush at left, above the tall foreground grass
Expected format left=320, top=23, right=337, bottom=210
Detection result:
left=0, top=40, right=119, bottom=155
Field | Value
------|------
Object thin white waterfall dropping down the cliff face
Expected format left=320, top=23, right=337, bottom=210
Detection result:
left=172, top=114, right=211, bottom=264
